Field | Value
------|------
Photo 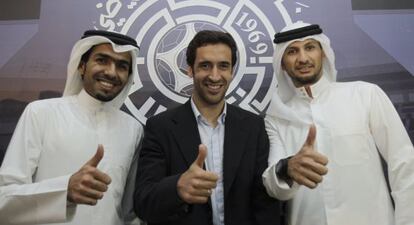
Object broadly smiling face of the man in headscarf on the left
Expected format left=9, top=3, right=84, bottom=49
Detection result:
left=78, top=44, right=131, bottom=102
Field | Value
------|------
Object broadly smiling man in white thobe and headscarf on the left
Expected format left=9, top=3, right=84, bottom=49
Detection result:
left=0, top=31, right=143, bottom=225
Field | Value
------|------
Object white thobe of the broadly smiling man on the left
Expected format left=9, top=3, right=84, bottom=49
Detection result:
left=0, top=90, right=143, bottom=225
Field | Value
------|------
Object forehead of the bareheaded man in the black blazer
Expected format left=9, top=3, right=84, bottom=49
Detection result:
left=196, top=43, right=231, bottom=62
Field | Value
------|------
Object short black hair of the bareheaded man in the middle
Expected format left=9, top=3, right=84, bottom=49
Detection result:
left=186, top=30, right=237, bottom=68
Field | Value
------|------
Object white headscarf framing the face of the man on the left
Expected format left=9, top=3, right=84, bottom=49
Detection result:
left=63, top=36, right=138, bottom=108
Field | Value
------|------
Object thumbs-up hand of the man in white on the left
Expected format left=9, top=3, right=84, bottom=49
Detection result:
left=68, top=144, right=111, bottom=205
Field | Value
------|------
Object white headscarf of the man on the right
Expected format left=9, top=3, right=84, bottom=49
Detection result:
left=266, top=21, right=337, bottom=124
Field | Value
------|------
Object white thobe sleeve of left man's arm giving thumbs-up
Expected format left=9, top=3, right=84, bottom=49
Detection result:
left=0, top=104, right=75, bottom=224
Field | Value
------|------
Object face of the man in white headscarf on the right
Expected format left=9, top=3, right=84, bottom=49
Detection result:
left=282, top=39, right=325, bottom=87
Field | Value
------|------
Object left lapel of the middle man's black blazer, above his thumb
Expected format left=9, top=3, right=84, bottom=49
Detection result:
left=173, top=101, right=201, bottom=166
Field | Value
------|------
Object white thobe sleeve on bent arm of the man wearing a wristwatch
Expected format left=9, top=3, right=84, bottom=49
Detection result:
left=262, top=116, right=299, bottom=200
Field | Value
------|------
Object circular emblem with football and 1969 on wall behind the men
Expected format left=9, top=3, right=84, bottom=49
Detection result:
left=94, top=0, right=300, bottom=124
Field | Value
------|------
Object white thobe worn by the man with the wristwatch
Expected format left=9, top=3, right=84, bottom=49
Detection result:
left=263, top=78, right=414, bottom=225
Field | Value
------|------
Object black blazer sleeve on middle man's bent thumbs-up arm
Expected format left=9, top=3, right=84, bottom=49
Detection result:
left=134, top=119, right=188, bottom=223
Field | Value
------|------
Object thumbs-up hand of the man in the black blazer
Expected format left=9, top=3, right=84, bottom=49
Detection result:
left=177, top=144, right=218, bottom=204
